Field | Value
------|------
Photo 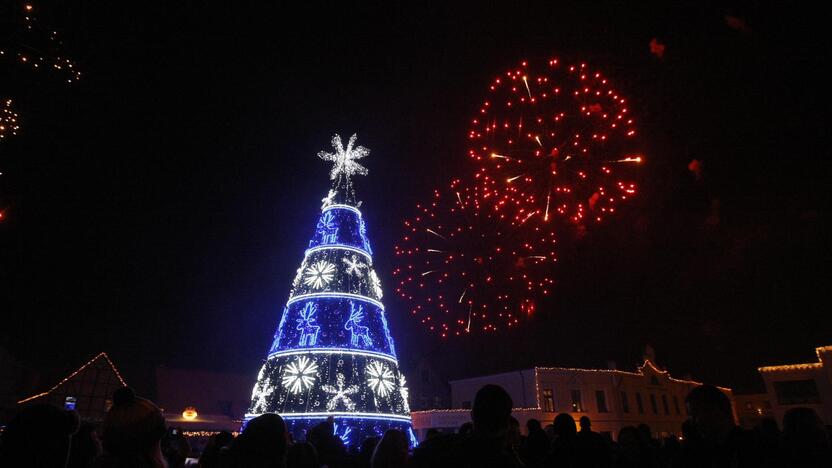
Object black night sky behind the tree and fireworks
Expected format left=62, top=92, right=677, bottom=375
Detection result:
left=0, top=0, right=832, bottom=398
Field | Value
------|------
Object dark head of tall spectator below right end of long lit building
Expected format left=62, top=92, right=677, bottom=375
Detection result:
left=685, top=385, right=734, bottom=440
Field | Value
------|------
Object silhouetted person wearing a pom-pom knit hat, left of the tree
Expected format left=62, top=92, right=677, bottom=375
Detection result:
left=95, top=387, right=167, bottom=468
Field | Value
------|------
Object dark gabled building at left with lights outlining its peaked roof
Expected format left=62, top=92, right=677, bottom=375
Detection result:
left=17, top=353, right=127, bottom=421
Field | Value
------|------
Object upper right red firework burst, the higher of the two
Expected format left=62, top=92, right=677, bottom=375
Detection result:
left=468, top=59, right=644, bottom=232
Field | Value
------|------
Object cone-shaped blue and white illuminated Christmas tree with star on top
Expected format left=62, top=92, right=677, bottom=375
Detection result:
left=246, top=135, right=413, bottom=445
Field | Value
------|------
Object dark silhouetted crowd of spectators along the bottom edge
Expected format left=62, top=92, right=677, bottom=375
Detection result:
left=0, top=385, right=832, bottom=468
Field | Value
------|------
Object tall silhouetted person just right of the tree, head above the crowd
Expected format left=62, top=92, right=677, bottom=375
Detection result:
left=412, top=384, right=521, bottom=468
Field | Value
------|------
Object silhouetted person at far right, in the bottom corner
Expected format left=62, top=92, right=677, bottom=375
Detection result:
left=781, top=408, right=832, bottom=468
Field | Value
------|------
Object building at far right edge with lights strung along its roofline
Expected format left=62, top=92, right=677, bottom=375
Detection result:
left=757, top=346, right=832, bottom=427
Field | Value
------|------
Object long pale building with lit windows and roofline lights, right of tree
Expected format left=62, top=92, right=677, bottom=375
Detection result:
left=412, top=359, right=733, bottom=440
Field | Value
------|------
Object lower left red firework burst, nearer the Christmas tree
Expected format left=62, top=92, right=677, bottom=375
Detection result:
left=393, top=179, right=557, bottom=337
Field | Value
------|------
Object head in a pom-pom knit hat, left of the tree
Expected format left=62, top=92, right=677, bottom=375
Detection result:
left=102, top=387, right=166, bottom=456
